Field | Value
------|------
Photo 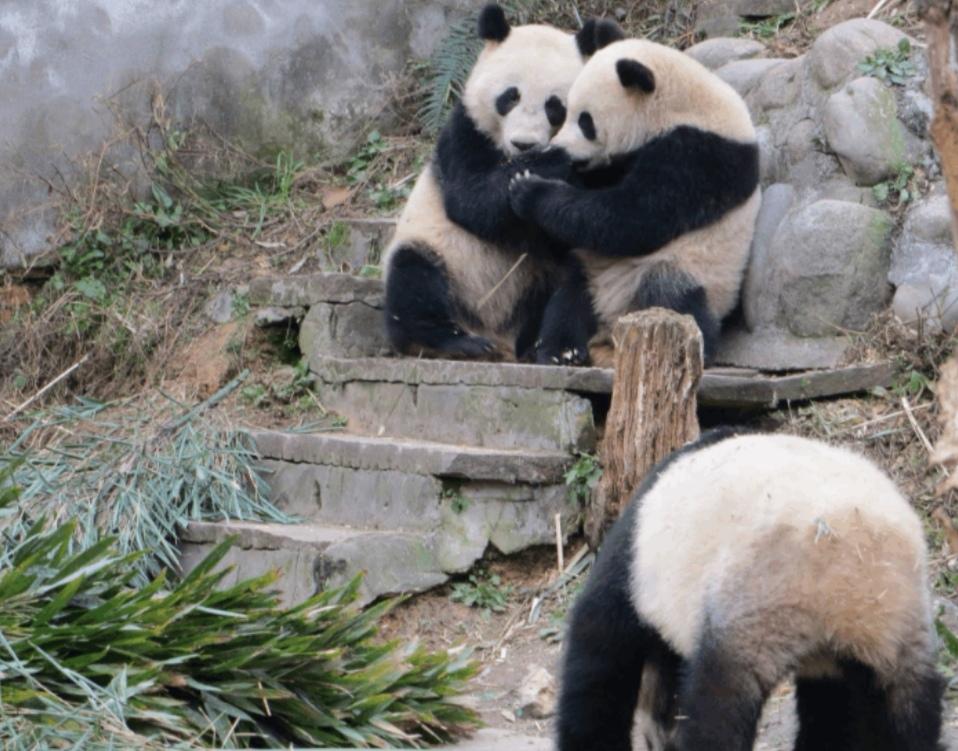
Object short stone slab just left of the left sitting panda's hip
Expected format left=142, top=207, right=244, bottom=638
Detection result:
left=249, top=273, right=384, bottom=308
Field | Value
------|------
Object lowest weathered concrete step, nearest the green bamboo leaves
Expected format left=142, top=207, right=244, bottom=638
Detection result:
left=180, top=521, right=448, bottom=604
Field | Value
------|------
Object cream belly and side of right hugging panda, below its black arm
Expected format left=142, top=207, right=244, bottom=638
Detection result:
left=576, top=189, right=761, bottom=327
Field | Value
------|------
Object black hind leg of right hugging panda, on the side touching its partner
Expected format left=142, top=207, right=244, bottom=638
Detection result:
left=535, top=256, right=599, bottom=365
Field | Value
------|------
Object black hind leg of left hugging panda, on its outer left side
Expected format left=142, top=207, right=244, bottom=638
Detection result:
left=384, top=245, right=494, bottom=357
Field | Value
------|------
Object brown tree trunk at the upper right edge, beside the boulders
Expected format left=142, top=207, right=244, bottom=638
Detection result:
left=918, top=0, right=958, bottom=250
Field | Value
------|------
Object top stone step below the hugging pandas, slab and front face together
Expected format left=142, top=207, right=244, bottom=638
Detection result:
left=313, top=357, right=603, bottom=452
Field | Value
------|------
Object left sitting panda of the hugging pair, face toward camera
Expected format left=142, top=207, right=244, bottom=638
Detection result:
left=384, top=5, right=583, bottom=357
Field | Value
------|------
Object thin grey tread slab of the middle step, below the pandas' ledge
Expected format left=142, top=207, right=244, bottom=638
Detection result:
left=252, top=431, right=570, bottom=485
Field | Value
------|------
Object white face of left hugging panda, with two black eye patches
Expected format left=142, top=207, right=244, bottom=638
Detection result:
left=463, top=25, right=582, bottom=156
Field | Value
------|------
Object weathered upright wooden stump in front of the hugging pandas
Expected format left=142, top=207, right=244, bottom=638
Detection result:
left=585, top=308, right=702, bottom=549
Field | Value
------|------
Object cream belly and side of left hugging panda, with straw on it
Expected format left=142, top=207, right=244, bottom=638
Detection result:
left=384, top=166, right=549, bottom=335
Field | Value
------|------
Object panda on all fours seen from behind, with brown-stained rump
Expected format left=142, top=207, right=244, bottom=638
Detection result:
left=558, top=430, right=944, bottom=751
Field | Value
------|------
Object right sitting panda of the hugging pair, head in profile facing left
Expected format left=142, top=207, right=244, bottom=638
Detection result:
left=510, top=21, right=761, bottom=364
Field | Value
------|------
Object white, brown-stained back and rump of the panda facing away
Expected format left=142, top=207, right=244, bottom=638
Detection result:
left=632, top=436, right=928, bottom=672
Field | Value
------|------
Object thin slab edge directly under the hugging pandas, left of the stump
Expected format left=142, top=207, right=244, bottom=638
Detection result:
left=310, top=356, right=612, bottom=394
